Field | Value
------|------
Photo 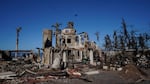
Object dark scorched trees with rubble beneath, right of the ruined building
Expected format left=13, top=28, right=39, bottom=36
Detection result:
left=102, top=19, right=150, bottom=68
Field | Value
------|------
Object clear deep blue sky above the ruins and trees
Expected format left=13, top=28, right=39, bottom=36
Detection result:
left=0, top=0, right=150, bottom=50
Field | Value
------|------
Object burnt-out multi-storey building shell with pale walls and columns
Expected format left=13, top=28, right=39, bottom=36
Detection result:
left=42, top=22, right=101, bottom=68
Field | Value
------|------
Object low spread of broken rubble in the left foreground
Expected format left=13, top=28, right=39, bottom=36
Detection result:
left=0, top=60, right=95, bottom=84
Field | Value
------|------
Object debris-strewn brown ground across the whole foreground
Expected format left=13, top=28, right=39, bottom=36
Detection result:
left=0, top=60, right=150, bottom=84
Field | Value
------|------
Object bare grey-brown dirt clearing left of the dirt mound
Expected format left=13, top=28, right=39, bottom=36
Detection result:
left=31, top=71, right=129, bottom=84
